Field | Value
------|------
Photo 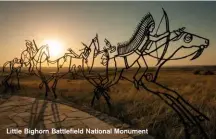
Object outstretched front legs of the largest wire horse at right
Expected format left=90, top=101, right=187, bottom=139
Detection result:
left=141, top=82, right=209, bottom=139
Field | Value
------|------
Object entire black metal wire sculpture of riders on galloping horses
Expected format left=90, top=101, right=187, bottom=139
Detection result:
left=2, top=9, right=209, bottom=139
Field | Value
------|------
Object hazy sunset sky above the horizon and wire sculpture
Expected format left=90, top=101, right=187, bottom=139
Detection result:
left=0, top=1, right=216, bottom=65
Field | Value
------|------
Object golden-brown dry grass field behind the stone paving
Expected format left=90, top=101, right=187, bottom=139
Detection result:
left=1, top=67, right=216, bottom=139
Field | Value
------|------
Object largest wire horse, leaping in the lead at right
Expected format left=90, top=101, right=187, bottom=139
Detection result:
left=91, top=11, right=209, bottom=139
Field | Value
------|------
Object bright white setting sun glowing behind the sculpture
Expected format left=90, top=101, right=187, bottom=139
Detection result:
left=44, top=40, right=63, bottom=57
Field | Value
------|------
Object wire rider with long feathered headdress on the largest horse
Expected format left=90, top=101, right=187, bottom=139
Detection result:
left=105, top=13, right=170, bottom=56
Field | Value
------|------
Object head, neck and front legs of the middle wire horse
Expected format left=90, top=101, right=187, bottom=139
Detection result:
left=71, top=34, right=111, bottom=107
